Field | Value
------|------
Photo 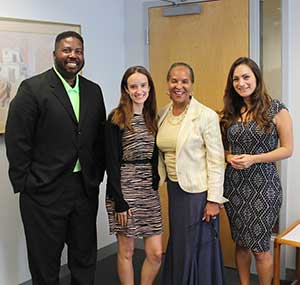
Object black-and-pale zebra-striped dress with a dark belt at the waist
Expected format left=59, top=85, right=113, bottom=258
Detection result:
left=106, top=115, right=162, bottom=238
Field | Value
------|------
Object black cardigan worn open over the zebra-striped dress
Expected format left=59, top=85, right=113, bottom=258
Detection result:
left=105, top=113, right=159, bottom=213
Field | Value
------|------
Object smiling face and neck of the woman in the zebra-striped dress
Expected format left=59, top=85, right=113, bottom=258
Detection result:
left=126, top=72, right=150, bottom=113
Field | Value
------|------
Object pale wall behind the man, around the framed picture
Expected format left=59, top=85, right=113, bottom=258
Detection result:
left=0, top=0, right=125, bottom=285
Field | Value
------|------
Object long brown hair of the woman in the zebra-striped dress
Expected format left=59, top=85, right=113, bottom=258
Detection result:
left=112, top=65, right=157, bottom=134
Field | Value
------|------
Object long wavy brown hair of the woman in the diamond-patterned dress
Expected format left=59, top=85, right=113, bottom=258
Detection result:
left=220, top=57, right=271, bottom=138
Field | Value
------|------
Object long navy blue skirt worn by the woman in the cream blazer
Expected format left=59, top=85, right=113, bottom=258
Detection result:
left=161, top=181, right=225, bottom=285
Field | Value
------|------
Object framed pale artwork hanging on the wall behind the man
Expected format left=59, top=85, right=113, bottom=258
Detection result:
left=0, top=17, right=81, bottom=134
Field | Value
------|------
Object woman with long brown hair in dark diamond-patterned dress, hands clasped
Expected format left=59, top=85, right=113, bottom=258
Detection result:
left=221, top=57, right=293, bottom=285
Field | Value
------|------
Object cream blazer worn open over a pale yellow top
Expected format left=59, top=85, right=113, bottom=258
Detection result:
left=158, top=97, right=227, bottom=203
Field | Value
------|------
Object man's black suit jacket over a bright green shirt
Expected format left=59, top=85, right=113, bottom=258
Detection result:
left=5, top=69, right=106, bottom=204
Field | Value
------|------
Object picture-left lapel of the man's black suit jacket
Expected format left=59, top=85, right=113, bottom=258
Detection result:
left=50, top=70, right=77, bottom=124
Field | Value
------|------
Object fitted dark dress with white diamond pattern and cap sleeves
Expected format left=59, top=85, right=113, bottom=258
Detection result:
left=224, top=100, right=286, bottom=252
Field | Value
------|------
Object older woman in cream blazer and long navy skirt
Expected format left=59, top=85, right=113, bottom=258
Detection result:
left=157, top=63, right=227, bottom=285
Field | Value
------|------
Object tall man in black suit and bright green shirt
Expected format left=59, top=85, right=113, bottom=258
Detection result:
left=5, top=31, right=106, bottom=285
